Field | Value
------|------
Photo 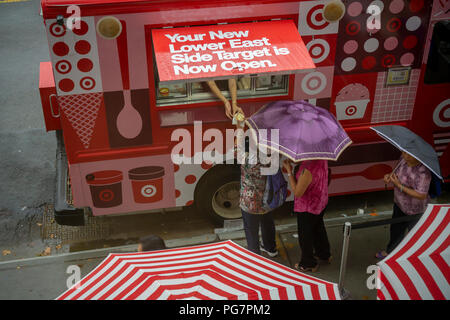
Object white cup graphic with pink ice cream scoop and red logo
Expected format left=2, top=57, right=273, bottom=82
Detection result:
left=334, top=83, right=370, bottom=120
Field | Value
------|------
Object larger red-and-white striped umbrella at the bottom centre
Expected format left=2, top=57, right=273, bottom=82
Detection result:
left=57, top=241, right=340, bottom=300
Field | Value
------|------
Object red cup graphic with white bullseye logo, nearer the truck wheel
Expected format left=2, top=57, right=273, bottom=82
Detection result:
left=128, top=166, right=164, bottom=203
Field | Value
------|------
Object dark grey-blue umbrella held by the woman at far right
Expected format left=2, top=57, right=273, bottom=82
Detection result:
left=371, top=125, right=442, bottom=180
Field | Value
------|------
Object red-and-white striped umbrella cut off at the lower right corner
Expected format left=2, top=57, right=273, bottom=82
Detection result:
left=377, top=204, right=450, bottom=300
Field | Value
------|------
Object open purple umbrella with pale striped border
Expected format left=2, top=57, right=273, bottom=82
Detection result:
left=246, top=100, right=352, bottom=162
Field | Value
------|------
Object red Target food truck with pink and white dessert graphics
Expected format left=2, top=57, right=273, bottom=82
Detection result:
left=39, top=0, right=450, bottom=225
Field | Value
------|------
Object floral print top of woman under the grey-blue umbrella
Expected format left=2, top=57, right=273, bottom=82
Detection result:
left=394, top=158, right=431, bottom=215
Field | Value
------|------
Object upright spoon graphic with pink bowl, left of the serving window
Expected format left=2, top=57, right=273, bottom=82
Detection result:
left=116, top=20, right=142, bottom=139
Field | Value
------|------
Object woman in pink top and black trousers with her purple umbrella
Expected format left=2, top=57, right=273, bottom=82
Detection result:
left=246, top=100, right=352, bottom=272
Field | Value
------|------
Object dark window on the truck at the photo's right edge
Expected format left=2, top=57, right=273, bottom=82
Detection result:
left=425, top=20, right=450, bottom=84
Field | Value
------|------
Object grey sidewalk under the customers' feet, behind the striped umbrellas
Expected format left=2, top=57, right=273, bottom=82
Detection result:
left=0, top=212, right=390, bottom=300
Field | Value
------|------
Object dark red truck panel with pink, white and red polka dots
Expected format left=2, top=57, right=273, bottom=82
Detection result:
left=335, top=0, right=431, bottom=75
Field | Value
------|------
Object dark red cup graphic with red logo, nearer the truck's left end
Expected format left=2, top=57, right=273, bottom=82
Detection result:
left=86, top=170, right=123, bottom=208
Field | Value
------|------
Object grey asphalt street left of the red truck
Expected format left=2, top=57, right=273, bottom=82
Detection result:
left=0, top=0, right=56, bottom=258
